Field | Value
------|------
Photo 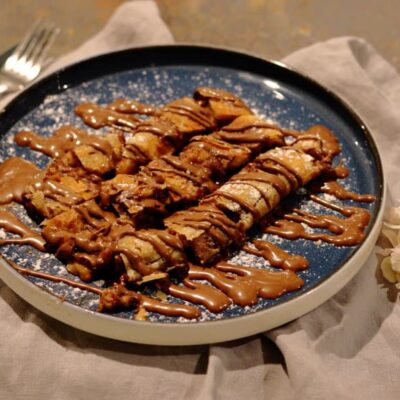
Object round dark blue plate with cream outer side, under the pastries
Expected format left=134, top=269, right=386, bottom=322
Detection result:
left=0, top=45, right=385, bottom=345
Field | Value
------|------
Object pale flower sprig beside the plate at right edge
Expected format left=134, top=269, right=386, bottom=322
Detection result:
left=380, top=207, right=400, bottom=289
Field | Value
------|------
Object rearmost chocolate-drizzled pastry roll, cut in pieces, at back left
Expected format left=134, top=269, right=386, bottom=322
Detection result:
left=25, top=88, right=250, bottom=222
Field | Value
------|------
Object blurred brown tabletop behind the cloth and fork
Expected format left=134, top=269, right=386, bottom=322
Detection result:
left=0, top=0, right=400, bottom=70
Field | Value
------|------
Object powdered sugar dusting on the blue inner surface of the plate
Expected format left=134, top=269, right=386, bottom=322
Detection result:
left=0, top=65, right=377, bottom=323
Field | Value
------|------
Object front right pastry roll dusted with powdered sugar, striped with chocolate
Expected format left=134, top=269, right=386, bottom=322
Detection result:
left=119, top=128, right=340, bottom=280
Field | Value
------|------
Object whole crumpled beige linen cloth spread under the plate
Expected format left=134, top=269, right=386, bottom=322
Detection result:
left=0, top=1, right=400, bottom=400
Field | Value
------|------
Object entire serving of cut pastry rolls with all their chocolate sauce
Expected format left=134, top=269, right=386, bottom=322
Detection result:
left=0, top=87, right=373, bottom=319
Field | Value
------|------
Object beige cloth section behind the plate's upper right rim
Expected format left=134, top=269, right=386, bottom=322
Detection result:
left=283, top=37, right=400, bottom=204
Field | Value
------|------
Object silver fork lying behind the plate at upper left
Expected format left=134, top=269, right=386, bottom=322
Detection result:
left=0, top=20, right=60, bottom=96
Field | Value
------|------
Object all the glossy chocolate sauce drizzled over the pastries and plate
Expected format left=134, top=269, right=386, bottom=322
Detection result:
left=0, top=88, right=375, bottom=319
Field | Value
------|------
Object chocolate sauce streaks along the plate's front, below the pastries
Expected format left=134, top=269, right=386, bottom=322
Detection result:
left=7, top=260, right=304, bottom=319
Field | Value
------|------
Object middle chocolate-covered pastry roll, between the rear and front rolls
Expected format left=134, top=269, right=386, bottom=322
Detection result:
left=100, top=115, right=284, bottom=225
